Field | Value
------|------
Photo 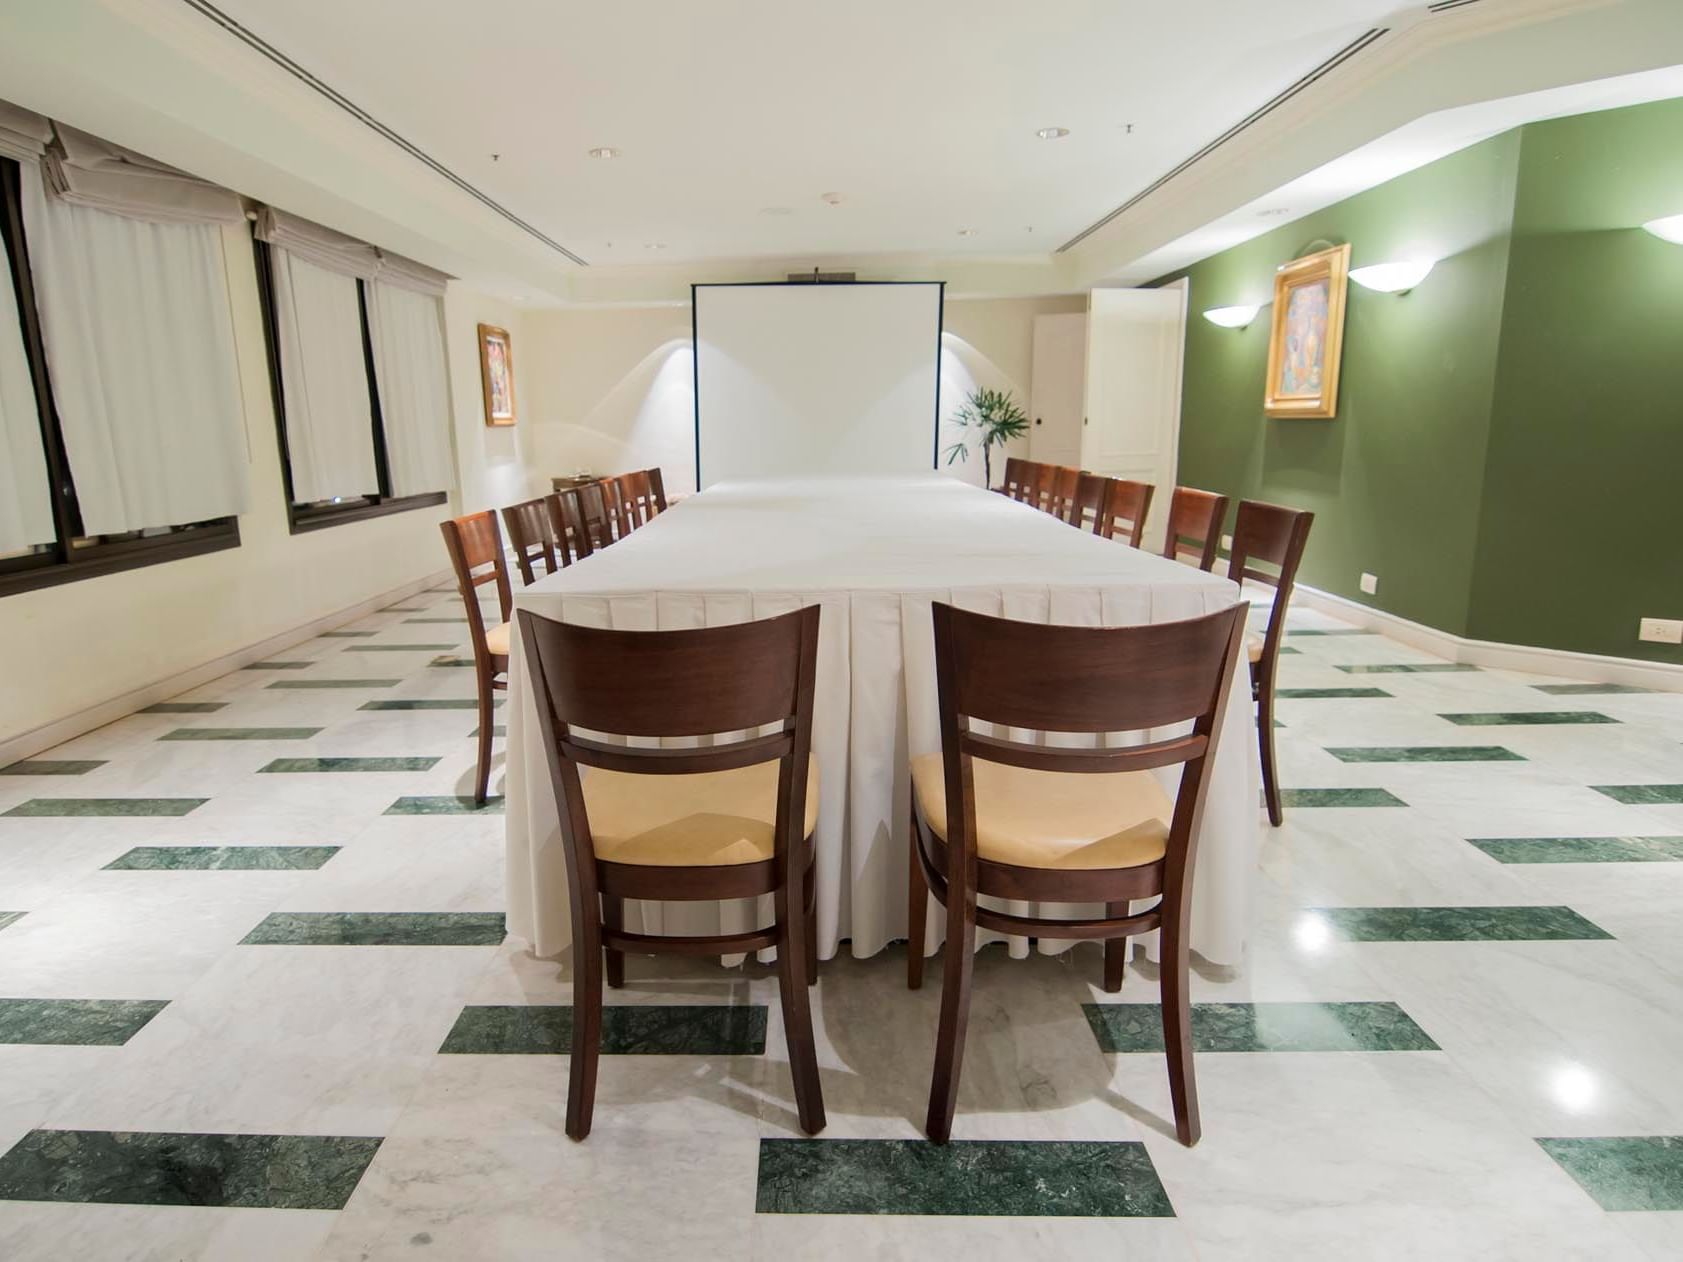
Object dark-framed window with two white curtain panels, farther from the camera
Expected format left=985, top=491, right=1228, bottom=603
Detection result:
left=252, top=209, right=454, bottom=533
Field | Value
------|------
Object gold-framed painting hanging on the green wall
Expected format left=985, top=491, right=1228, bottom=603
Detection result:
left=1262, top=244, right=1350, bottom=417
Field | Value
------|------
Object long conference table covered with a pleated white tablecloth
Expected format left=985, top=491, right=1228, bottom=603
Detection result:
left=505, top=475, right=1261, bottom=966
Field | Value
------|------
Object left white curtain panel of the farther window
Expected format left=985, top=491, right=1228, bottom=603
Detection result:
left=269, top=247, right=380, bottom=503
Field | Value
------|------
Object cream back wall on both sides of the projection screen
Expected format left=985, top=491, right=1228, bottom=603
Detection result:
left=515, top=294, right=1086, bottom=491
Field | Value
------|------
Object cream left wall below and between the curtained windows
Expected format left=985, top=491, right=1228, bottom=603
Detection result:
left=0, top=227, right=532, bottom=744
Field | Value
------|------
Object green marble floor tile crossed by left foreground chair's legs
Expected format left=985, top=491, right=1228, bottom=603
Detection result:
left=439, top=1003, right=766, bottom=1057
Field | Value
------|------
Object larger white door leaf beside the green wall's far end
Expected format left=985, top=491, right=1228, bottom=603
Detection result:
left=1080, top=281, right=1187, bottom=552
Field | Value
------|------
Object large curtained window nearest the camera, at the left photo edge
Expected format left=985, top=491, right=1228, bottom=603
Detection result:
left=0, top=154, right=246, bottom=596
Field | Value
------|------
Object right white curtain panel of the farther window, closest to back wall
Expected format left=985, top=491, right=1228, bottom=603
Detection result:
left=369, top=281, right=456, bottom=495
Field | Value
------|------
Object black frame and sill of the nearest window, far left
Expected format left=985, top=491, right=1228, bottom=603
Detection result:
left=0, top=158, right=239, bottom=597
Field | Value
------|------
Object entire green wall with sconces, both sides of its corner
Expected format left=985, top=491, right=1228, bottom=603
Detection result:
left=1163, top=101, right=1683, bottom=661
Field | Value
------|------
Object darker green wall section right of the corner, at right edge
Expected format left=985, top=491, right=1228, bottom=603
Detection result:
left=1469, top=101, right=1683, bottom=661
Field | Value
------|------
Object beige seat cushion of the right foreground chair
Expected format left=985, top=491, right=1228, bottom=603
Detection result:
left=912, top=754, right=1175, bottom=870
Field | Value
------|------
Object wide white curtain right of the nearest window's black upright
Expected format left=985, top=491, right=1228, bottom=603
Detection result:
left=22, top=167, right=247, bottom=535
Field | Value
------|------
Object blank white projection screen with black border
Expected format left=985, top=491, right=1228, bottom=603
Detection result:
left=692, top=281, right=942, bottom=490
